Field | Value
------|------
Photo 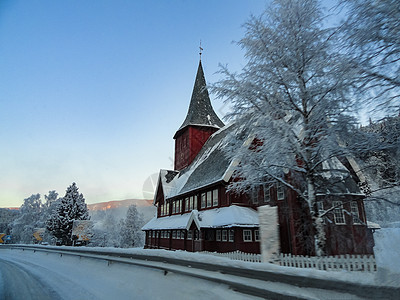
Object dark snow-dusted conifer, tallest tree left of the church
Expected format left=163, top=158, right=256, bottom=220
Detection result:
left=46, top=182, right=90, bottom=245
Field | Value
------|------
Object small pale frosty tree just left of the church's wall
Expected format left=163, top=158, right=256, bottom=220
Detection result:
left=120, top=204, right=144, bottom=248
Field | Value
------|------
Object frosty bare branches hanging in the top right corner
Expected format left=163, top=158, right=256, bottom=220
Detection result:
left=341, top=0, right=400, bottom=112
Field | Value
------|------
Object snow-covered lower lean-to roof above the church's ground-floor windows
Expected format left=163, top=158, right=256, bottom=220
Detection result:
left=142, top=205, right=259, bottom=230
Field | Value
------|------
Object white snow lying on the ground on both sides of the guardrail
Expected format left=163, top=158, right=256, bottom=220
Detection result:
left=0, top=228, right=400, bottom=300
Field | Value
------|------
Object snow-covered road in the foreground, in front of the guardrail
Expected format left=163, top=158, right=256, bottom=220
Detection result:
left=0, top=249, right=257, bottom=300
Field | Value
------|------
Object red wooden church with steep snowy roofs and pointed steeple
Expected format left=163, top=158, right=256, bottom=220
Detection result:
left=143, top=61, right=373, bottom=255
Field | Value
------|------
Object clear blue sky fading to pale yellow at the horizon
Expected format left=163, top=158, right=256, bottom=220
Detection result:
left=0, top=0, right=342, bottom=207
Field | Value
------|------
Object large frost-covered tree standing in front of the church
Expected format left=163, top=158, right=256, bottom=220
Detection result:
left=212, top=0, right=382, bottom=255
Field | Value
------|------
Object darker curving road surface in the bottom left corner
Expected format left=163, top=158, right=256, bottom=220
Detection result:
left=0, top=258, right=59, bottom=300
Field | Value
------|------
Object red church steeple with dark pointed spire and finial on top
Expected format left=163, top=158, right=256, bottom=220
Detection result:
left=174, top=60, right=224, bottom=171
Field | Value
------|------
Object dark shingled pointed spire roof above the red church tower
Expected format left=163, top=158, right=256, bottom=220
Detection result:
left=174, top=61, right=224, bottom=138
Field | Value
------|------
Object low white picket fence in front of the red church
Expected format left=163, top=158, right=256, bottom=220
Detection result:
left=202, top=251, right=376, bottom=272
